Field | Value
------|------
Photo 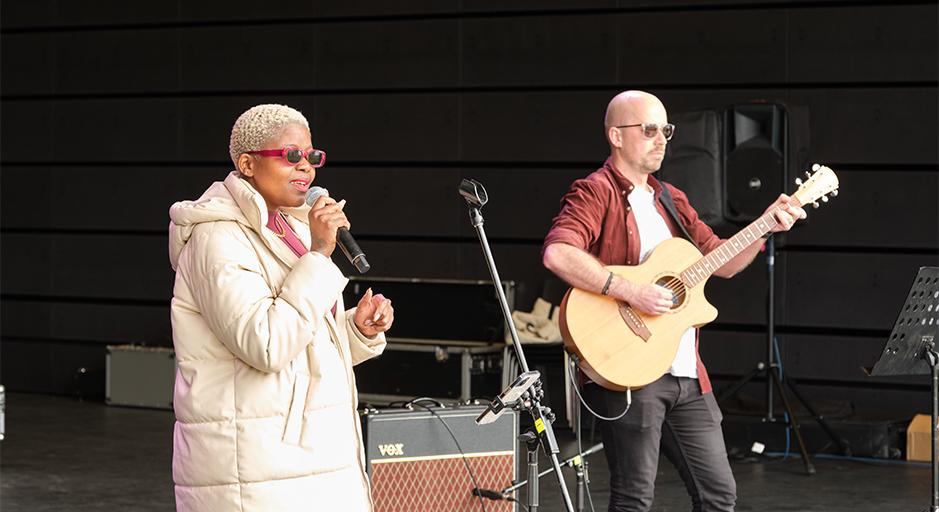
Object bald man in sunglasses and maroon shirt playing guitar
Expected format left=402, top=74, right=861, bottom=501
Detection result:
left=543, top=91, right=805, bottom=511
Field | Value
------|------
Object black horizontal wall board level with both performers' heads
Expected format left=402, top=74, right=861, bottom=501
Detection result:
left=3, top=87, right=939, bottom=166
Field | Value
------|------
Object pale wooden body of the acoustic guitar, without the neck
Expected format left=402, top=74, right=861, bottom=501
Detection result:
left=560, top=238, right=717, bottom=391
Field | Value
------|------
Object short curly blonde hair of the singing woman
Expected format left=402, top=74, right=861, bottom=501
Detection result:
left=228, top=104, right=310, bottom=168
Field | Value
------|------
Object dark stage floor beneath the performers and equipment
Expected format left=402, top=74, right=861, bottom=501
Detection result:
left=0, top=393, right=930, bottom=512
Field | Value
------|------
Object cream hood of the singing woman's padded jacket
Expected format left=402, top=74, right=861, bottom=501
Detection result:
left=169, top=171, right=310, bottom=270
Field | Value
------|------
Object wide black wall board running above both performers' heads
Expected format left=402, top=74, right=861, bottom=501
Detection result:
left=4, top=5, right=937, bottom=94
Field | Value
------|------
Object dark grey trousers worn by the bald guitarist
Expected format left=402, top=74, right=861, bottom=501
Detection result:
left=584, top=375, right=737, bottom=512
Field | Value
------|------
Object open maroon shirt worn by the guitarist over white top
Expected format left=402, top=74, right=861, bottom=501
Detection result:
left=544, top=159, right=724, bottom=393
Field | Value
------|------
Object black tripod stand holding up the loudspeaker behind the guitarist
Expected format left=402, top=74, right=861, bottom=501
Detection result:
left=717, top=236, right=850, bottom=475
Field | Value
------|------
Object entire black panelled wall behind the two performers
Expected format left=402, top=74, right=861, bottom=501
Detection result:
left=0, top=0, right=939, bottom=420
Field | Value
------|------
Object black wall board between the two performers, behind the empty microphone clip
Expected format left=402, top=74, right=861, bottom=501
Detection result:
left=315, top=167, right=586, bottom=242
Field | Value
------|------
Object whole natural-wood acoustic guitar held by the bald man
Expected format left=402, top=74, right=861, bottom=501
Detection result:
left=560, top=164, right=838, bottom=391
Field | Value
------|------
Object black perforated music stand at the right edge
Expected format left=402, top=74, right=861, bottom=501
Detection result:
left=870, top=267, right=939, bottom=512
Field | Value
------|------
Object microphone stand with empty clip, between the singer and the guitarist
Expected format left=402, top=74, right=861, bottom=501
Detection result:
left=460, top=179, right=574, bottom=512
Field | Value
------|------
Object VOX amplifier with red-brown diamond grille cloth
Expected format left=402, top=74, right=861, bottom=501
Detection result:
left=362, top=406, right=518, bottom=512
